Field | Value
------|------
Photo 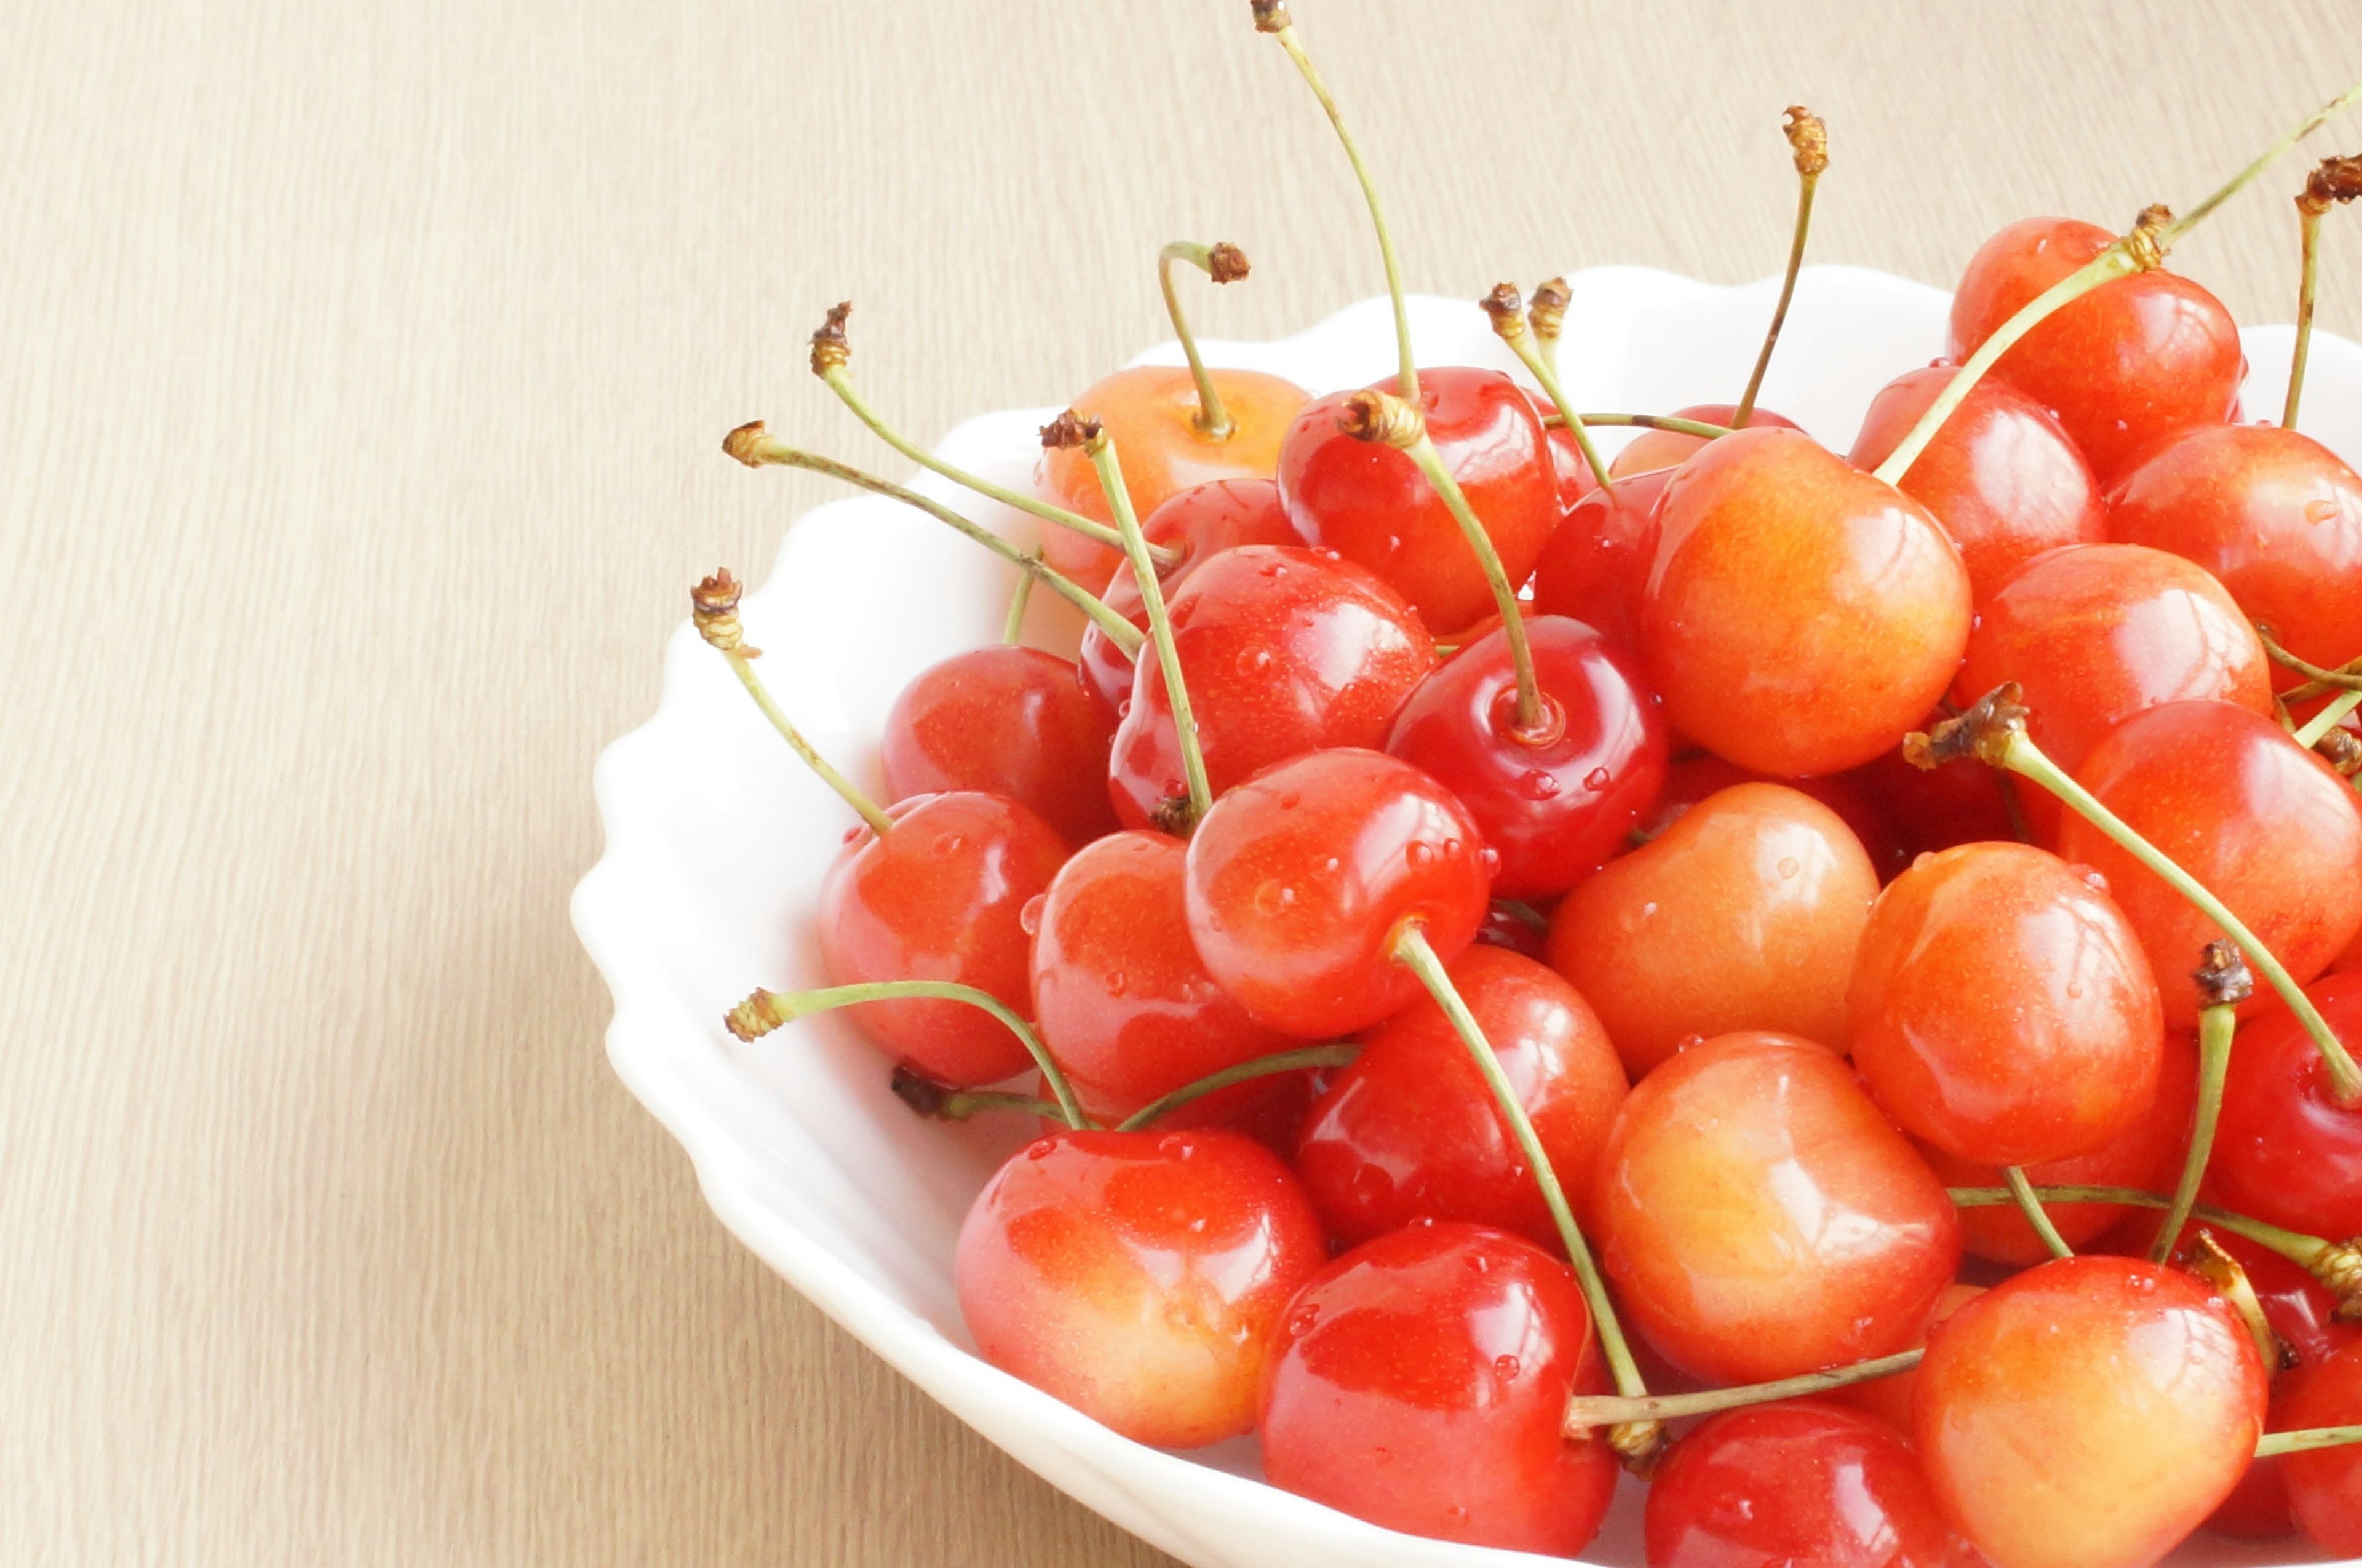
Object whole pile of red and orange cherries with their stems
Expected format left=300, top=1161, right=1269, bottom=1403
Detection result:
left=697, top=0, right=2362, bottom=1568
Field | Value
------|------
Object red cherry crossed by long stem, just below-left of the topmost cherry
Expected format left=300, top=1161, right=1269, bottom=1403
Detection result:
left=1850, top=364, right=2107, bottom=600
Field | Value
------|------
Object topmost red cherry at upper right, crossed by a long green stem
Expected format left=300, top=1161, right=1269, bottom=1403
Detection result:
left=1949, top=217, right=2246, bottom=484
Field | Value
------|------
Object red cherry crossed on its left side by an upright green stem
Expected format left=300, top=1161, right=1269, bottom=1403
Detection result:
left=1108, top=546, right=1436, bottom=827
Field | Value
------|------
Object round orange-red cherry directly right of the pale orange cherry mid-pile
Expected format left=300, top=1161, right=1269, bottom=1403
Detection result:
left=1847, top=843, right=2166, bottom=1164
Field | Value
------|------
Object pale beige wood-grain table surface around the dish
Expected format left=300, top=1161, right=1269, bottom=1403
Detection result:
left=0, top=0, right=2362, bottom=1568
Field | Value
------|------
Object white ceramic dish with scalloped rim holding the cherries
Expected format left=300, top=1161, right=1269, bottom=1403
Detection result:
left=574, top=267, right=2362, bottom=1568
